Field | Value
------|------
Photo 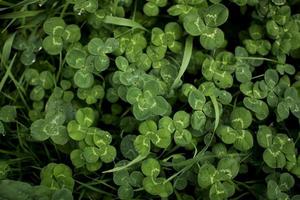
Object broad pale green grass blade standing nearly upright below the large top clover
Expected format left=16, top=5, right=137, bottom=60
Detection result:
left=171, top=36, right=193, bottom=89
